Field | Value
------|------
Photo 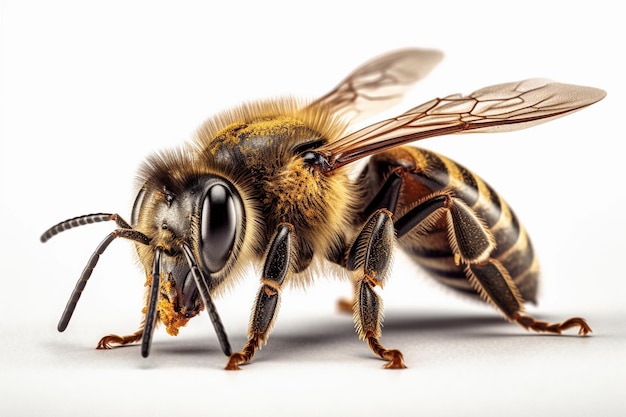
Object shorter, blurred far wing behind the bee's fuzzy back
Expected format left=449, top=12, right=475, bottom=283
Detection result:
left=309, top=49, right=443, bottom=121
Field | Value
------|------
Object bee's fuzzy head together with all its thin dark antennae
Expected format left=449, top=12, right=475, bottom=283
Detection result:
left=41, top=150, right=235, bottom=357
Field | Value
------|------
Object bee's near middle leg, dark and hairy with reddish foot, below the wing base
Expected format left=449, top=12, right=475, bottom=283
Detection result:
left=346, top=209, right=406, bottom=369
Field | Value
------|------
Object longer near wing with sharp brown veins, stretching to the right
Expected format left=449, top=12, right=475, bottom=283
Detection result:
left=317, top=79, right=606, bottom=169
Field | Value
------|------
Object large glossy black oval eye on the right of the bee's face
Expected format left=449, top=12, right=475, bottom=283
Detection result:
left=200, top=184, right=239, bottom=272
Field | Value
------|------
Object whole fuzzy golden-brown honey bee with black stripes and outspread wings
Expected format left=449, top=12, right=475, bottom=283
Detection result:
left=41, top=49, right=606, bottom=370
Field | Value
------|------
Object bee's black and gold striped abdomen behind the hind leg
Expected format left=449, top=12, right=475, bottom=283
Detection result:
left=359, top=147, right=539, bottom=302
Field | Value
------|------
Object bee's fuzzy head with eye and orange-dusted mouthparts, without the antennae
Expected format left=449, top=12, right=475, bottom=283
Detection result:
left=131, top=151, right=245, bottom=317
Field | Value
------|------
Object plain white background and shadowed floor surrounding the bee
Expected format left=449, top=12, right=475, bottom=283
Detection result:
left=0, top=0, right=626, bottom=416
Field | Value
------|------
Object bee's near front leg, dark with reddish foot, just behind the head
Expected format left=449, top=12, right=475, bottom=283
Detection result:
left=226, top=223, right=293, bottom=370
